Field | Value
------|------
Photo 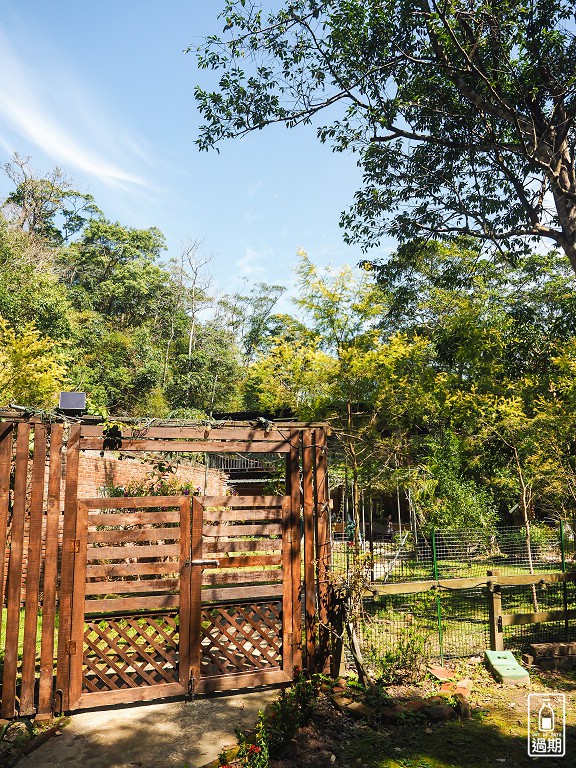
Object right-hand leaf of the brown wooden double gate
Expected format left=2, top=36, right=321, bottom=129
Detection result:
left=190, top=496, right=294, bottom=693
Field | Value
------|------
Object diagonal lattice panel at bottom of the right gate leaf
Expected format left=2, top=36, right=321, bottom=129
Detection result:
left=201, top=601, right=282, bottom=677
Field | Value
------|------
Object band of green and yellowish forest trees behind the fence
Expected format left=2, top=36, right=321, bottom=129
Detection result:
left=0, top=157, right=576, bottom=528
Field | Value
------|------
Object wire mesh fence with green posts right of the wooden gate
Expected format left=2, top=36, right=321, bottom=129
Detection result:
left=332, top=523, right=576, bottom=664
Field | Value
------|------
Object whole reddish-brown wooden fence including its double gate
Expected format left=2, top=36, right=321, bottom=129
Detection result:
left=0, top=418, right=330, bottom=719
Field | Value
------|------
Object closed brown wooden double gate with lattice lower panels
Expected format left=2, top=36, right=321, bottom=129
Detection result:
left=63, top=496, right=294, bottom=710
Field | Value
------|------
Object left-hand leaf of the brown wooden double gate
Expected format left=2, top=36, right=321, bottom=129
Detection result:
left=63, top=496, right=190, bottom=709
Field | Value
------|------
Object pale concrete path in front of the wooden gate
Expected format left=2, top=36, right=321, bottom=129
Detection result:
left=18, top=690, right=278, bottom=768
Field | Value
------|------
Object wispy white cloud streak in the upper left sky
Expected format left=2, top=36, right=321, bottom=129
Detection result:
left=0, top=30, right=151, bottom=191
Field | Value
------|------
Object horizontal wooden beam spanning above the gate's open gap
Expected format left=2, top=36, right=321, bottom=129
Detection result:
left=80, top=437, right=290, bottom=453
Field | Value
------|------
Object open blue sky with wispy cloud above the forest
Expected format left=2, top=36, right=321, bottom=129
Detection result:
left=0, top=0, right=392, bottom=302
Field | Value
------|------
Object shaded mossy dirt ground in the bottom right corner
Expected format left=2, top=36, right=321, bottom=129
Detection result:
left=270, top=660, right=576, bottom=768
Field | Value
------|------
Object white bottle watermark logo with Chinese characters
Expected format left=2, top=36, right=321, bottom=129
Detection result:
left=528, top=693, right=566, bottom=757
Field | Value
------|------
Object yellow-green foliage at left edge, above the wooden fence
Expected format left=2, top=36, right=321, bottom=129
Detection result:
left=0, top=317, right=66, bottom=408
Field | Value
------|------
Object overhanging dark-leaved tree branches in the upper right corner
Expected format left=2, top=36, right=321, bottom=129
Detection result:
left=196, top=0, right=576, bottom=270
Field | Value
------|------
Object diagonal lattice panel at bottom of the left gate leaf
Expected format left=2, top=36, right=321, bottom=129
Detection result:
left=82, top=615, right=178, bottom=692
